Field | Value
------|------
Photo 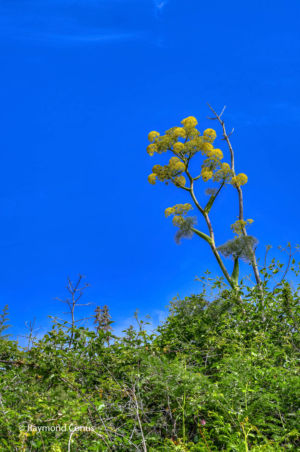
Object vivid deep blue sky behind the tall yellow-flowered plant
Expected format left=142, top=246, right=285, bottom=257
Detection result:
left=0, top=0, right=300, bottom=340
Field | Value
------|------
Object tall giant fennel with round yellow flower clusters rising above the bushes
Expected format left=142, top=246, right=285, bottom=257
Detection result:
left=147, top=107, right=262, bottom=290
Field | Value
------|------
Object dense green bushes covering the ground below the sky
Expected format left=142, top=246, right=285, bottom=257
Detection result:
left=0, top=266, right=300, bottom=452
